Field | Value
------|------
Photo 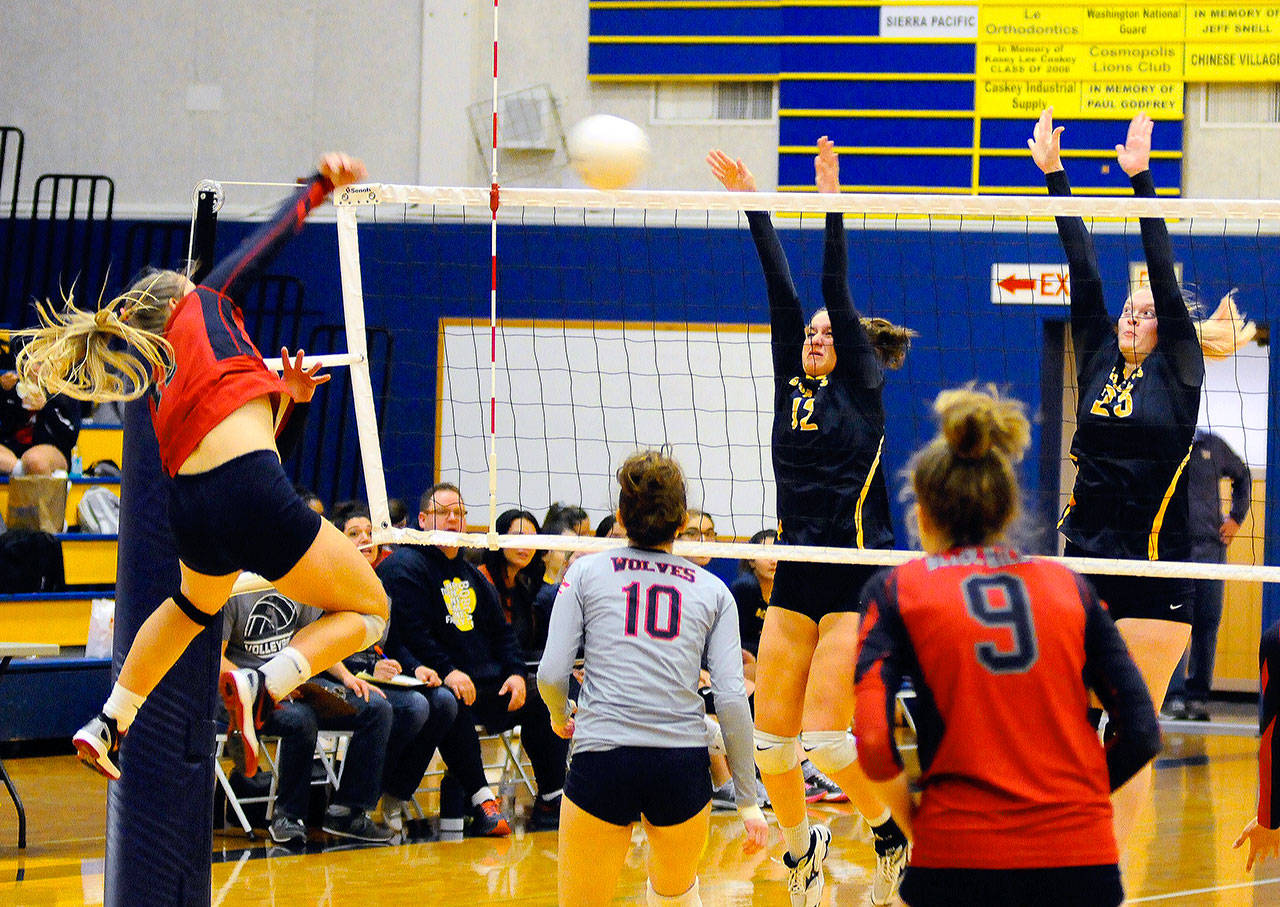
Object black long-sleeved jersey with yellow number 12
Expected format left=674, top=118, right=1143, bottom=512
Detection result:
left=746, top=211, right=893, bottom=548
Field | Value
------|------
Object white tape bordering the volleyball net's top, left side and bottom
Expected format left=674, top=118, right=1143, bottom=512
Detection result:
left=334, top=183, right=1280, bottom=582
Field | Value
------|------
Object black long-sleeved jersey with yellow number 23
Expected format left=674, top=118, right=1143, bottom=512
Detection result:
left=1047, top=170, right=1204, bottom=560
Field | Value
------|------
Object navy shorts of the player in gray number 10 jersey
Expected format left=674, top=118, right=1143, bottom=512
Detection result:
left=564, top=746, right=712, bottom=825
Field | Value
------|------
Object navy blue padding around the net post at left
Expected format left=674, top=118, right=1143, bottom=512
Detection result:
left=105, top=398, right=221, bottom=907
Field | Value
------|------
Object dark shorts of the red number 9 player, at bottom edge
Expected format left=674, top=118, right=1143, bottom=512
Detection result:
left=901, top=864, right=1124, bottom=907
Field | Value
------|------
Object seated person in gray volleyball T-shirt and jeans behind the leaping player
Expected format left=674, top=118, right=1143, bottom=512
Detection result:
left=223, top=590, right=394, bottom=844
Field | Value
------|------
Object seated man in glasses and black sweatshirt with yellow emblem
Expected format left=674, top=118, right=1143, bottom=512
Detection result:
left=378, top=482, right=568, bottom=834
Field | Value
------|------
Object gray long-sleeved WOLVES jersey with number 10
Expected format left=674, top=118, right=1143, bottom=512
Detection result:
left=538, top=548, right=754, bottom=803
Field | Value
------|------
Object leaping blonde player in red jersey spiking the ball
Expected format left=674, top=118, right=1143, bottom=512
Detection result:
left=18, top=154, right=388, bottom=778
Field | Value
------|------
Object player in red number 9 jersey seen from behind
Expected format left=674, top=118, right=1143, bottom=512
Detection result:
left=856, top=389, right=1160, bottom=907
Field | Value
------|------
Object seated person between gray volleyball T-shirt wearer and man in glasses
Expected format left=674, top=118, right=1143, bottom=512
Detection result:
left=333, top=500, right=458, bottom=832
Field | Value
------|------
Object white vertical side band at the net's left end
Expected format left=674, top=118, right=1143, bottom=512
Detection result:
left=337, top=205, right=392, bottom=530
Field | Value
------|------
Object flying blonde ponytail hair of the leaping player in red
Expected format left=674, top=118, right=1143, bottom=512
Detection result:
left=13, top=271, right=189, bottom=403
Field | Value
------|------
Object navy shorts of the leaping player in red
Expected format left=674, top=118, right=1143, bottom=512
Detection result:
left=169, top=450, right=320, bottom=582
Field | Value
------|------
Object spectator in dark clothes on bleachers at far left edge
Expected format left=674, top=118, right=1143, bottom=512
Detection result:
left=0, top=344, right=82, bottom=476
